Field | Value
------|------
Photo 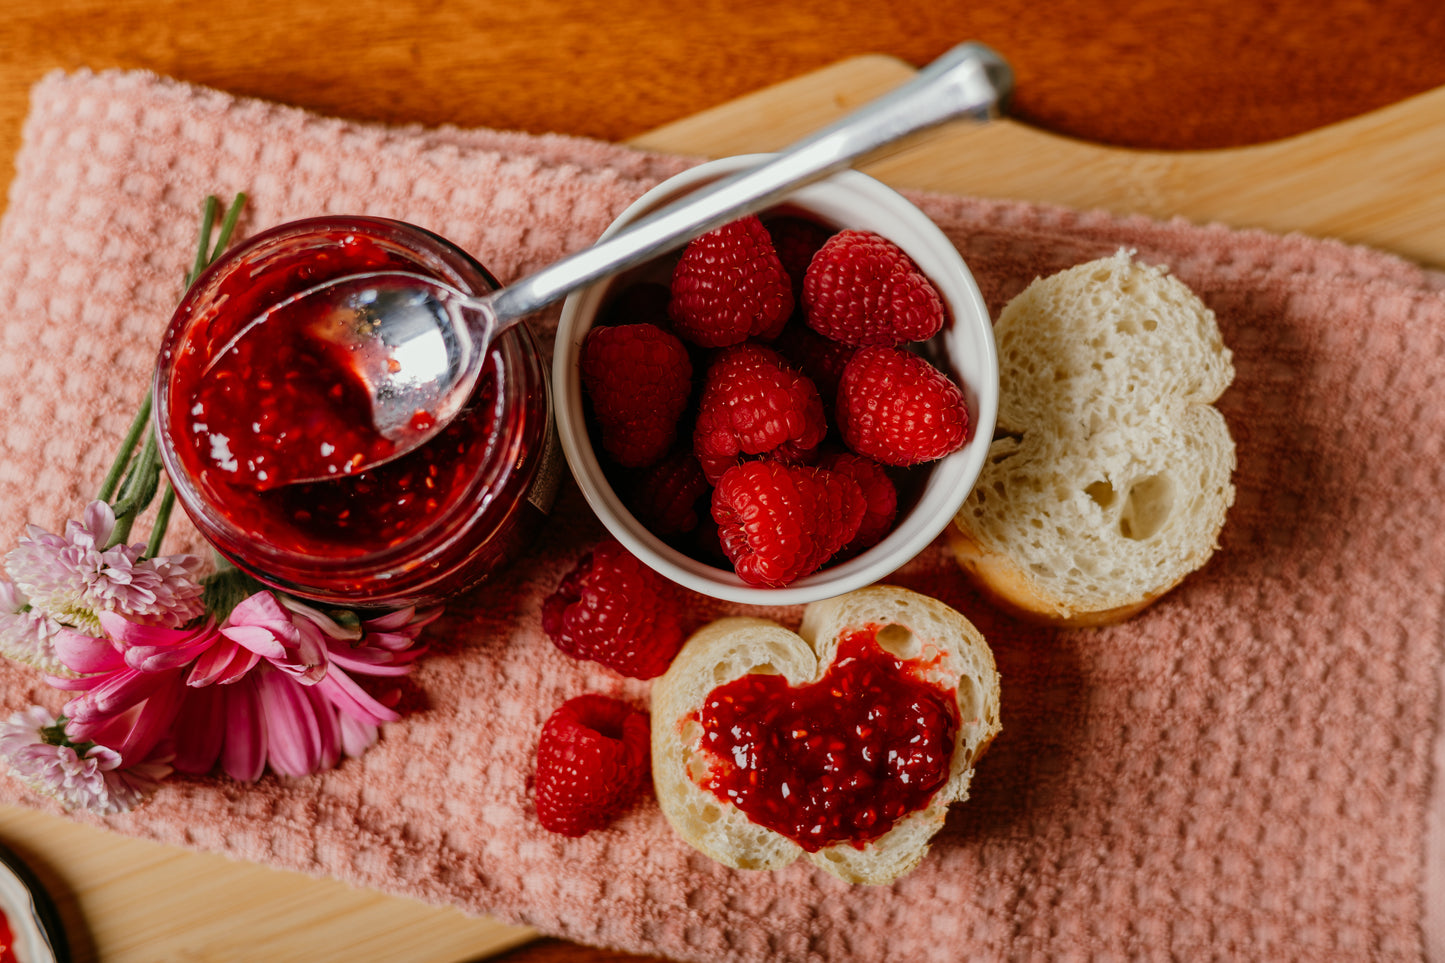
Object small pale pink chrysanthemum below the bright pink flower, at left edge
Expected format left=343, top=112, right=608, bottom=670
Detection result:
left=0, top=706, right=171, bottom=816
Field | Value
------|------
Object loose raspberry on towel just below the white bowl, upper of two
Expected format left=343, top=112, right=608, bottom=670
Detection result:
left=542, top=538, right=682, bottom=678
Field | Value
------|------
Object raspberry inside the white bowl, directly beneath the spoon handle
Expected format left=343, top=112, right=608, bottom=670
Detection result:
left=668, top=215, right=793, bottom=347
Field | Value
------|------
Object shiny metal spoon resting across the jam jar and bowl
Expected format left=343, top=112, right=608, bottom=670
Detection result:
left=231, top=43, right=1013, bottom=484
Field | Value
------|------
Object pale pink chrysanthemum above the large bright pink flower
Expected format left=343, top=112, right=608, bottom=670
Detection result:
left=6, top=502, right=202, bottom=633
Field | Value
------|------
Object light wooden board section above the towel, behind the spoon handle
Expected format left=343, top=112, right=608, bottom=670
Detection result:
left=644, top=56, right=1445, bottom=266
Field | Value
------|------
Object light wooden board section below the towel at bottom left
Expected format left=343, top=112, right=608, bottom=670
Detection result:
left=0, top=807, right=535, bottom=963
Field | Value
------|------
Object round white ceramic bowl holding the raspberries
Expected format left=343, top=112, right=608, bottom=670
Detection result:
left=552, top=155, right=998, bottom=604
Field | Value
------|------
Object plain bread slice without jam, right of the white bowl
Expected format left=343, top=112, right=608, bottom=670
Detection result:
left=951, top=250, right=1235, bottom=626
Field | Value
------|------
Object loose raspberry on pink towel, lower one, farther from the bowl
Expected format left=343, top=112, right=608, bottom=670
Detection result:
left=536, top=694, right=652, bottom=837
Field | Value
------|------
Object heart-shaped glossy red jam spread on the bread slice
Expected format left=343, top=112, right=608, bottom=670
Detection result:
left=698, top=626, right=959, bottom=852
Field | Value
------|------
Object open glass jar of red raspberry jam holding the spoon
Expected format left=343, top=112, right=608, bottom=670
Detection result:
left=155, top=217, right=559, bottom=607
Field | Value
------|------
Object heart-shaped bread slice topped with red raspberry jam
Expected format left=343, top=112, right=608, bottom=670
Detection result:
left=652, top=586, right=1000, bottom=883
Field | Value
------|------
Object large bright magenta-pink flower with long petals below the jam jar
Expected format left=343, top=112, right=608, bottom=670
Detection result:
left=33, top=581, right=427, bottom=782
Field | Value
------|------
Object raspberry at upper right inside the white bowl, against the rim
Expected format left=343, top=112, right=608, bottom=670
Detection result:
left=803, top=231, right=944, bottom=346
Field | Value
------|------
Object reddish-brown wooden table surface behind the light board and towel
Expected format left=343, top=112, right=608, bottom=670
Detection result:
left=0, top=0, right=1445, bottom=963
